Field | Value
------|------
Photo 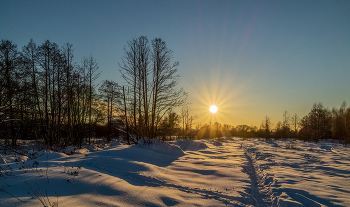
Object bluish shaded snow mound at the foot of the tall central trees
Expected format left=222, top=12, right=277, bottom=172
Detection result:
left=137, top=139, right=185, bottom=157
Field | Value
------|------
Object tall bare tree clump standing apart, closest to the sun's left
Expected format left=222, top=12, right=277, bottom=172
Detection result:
left=119, top=36, right=186, bottom=138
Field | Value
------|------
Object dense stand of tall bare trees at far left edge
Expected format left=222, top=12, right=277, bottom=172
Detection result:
left=0, top=39, right=103, bottom=147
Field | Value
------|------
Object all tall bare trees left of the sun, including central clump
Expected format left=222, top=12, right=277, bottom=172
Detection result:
left=0, top=36, right=186, bottom=148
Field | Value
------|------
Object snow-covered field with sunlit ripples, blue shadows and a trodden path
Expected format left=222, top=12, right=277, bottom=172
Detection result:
left=0, top=138, right=350, bottom=207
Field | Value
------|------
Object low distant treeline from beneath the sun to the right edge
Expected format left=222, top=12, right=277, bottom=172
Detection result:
left=195, top=102, right=350, bottom=142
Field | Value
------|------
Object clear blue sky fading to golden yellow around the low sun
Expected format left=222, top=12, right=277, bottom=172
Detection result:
left=0, top=0, right=350, bottom=127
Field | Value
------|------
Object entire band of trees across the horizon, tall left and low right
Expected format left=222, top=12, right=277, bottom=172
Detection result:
left=0, top=36, right=350, bottom=150
